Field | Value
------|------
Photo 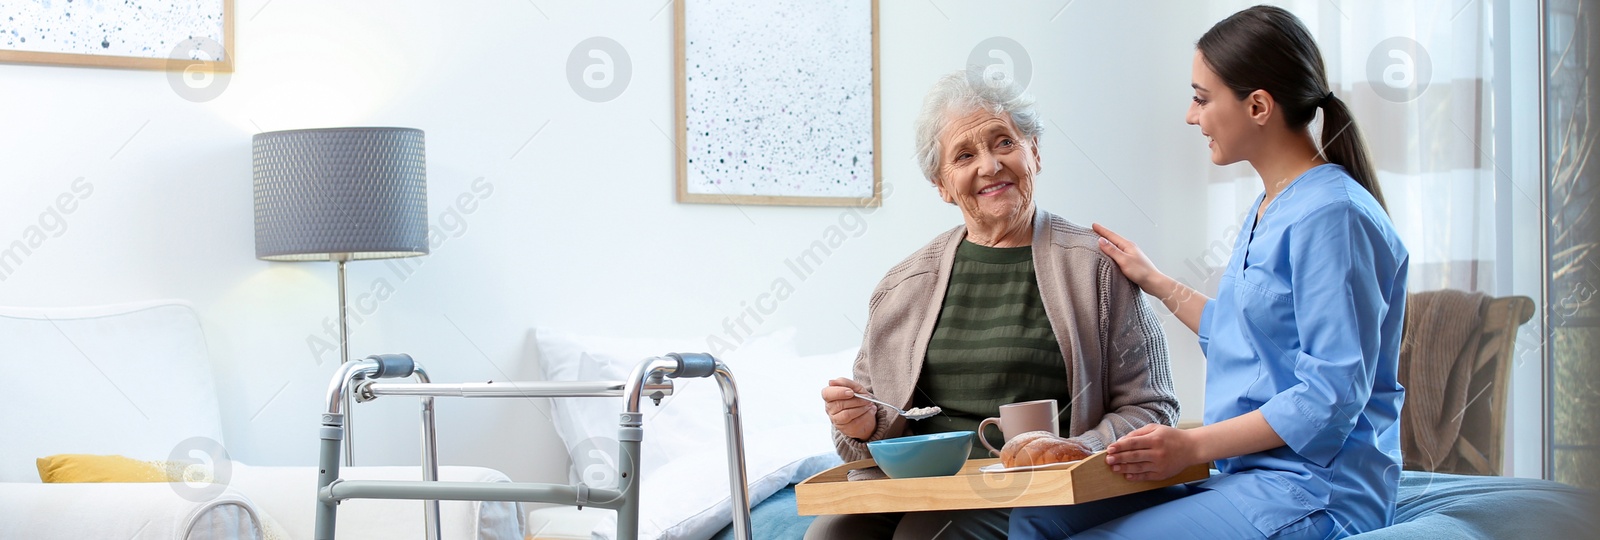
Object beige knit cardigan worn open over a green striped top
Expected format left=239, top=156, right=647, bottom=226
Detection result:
left=834, top=211, right=1178, bottom=462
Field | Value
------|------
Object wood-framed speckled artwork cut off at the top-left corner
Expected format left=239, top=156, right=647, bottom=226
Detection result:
left=0, top=0, right=234, bottom=72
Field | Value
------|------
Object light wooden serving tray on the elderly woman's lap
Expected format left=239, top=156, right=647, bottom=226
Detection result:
left=795, top=451, right=1211, bottom=516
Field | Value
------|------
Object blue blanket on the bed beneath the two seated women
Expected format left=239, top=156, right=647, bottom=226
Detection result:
left=712, top=471, right=1600, bottom=540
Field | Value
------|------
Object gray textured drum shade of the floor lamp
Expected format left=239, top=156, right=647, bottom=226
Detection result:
left=253, top=128, right=427, bottom=260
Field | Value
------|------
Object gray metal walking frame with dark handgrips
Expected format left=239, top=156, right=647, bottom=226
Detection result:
left=315, top=353, right=750, bottom=540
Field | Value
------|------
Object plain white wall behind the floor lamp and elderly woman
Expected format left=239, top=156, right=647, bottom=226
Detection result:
left=0, top=0, right=1213, bottom=481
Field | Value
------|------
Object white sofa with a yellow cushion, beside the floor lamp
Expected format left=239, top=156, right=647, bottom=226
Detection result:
left=0, top=302, right=523, bottom=540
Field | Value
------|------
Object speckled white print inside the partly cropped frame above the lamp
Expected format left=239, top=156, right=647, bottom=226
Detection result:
left=0, top=0, right=224, bottom=59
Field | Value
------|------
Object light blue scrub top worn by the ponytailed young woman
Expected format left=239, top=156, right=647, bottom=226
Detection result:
left=1200, top=165, right=1408, bottom=537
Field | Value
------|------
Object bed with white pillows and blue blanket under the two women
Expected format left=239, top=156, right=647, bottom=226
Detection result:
left=528, top=322, right=1600, bottom=540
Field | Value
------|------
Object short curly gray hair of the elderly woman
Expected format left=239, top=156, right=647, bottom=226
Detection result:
left=917, top=66, right=1045, bottom=184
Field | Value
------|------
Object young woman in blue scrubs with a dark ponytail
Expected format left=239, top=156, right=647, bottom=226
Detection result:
left=1010, top=6, right=1408, bottom=540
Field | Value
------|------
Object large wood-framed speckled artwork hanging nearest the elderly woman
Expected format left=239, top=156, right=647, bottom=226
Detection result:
left=675, top=0, right=883, bottom=206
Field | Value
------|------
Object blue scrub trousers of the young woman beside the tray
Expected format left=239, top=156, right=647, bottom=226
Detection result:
left=1010, top=484, right=1347, bottom=540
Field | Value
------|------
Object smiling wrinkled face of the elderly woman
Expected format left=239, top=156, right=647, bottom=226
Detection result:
left=936, top=109, right=1038, bottom=227
